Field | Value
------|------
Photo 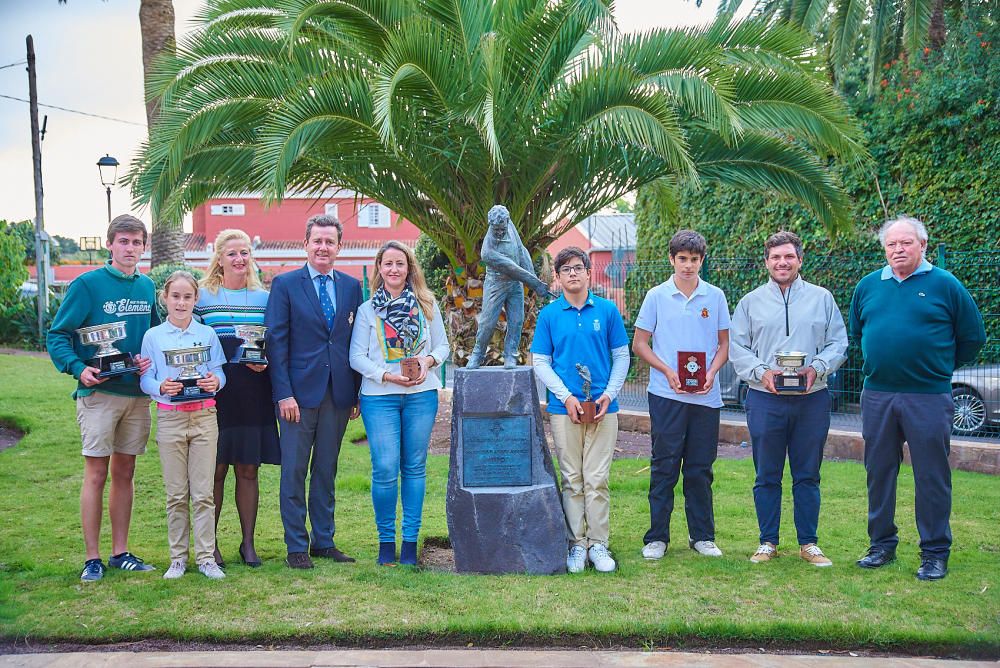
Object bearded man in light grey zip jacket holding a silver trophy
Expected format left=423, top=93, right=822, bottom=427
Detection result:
left=729, top=232, right=847, bottom=566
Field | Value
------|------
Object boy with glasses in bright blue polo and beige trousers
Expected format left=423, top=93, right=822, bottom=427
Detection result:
left=531, top=246, right=629, bottom=573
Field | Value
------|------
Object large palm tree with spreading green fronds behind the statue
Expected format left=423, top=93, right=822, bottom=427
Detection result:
left=130, top=0, right=866, bottom=360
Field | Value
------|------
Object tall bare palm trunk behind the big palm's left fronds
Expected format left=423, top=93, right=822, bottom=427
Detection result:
left=139, top=0, right=184, bottom=267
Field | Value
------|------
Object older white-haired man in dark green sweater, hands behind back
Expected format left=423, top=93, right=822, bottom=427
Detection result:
left=850, top=217, right=986, bottom=580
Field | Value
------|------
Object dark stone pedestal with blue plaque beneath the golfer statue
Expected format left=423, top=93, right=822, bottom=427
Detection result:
left=447, top=367, right=567, bottom=575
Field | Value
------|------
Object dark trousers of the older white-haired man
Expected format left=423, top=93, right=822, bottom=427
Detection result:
left=861, top=390, right=955, bottom=559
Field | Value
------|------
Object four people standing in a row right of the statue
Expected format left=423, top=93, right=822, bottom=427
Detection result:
left=531, top=217, right=986, bottom=580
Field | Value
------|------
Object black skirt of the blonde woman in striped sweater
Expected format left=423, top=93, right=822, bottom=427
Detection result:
left=215, top=336, right=281, bottom=465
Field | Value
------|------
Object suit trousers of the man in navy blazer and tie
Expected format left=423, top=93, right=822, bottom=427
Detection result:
left=278, top=390, right=351, bottom=552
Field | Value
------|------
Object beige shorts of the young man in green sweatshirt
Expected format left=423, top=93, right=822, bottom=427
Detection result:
left=76, top=392, right=152, bottom=457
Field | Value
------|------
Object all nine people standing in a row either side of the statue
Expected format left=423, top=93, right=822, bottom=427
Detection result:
left=47, top=215, right=985, bottom=581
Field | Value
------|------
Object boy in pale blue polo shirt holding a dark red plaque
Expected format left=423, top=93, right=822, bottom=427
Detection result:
left=632, top=230, right=729, bottom=559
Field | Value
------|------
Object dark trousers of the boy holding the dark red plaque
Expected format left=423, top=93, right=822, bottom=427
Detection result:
left=643, top=394, right=720, bottom=543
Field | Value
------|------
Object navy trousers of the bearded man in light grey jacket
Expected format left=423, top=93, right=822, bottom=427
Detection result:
left=746, top=388, right=830, bottom=545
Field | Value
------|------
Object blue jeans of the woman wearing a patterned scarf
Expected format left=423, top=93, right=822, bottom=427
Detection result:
left=361, top=390, right=438, bottom=543
